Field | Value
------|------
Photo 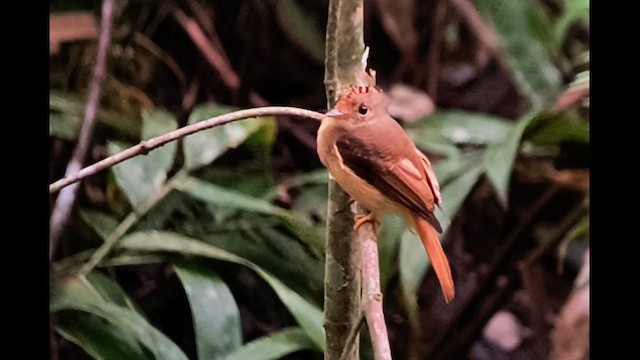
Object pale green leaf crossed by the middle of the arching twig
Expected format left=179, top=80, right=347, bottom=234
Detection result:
left=108, top=110, right=178, bottom=208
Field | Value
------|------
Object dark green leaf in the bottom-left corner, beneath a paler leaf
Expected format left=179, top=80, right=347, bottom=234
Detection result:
left=54, top=310, right=150, bottom=360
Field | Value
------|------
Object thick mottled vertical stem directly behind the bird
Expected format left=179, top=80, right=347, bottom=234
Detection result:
left=324, top=0, right=364, bottom=360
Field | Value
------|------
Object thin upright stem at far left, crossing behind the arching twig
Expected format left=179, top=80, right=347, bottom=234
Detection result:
left=49, top=0, right=115, bottom=260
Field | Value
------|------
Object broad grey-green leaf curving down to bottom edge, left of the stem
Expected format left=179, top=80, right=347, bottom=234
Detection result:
left=174, top=263, right=242, bottom=359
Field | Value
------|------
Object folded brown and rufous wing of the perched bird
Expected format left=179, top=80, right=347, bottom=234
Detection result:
left=336, top=128, right=442, bottom=232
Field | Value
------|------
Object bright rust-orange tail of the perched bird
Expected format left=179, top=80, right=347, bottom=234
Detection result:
left=413, top=215, right=456, bottom=303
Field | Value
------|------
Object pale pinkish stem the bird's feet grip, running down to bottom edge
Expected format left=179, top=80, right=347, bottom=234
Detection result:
left=357, top=211, right=391, bottom=360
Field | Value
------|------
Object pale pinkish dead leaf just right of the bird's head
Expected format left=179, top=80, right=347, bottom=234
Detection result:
left=388, top=84, right=436, bottom=122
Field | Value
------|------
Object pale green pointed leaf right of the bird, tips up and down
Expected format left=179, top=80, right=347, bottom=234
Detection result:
left=483, top=115, right=534, bottom=207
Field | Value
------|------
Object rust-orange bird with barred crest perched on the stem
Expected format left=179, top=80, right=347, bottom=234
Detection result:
left=317, top=85, right=455, bottom=303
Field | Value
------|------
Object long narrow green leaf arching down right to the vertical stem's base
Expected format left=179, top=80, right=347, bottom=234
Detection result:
left=118, top=231, right=324, bottom=349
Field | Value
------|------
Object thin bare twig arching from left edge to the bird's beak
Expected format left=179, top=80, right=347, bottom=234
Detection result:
left=49, top=106, right=324, bottom=193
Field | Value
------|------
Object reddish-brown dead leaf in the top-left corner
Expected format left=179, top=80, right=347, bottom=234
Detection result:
left=49, top=12, right=98, bottom=54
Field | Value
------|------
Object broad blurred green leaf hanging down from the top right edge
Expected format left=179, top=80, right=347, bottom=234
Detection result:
left=473, top=0, right=562, bottom=111
